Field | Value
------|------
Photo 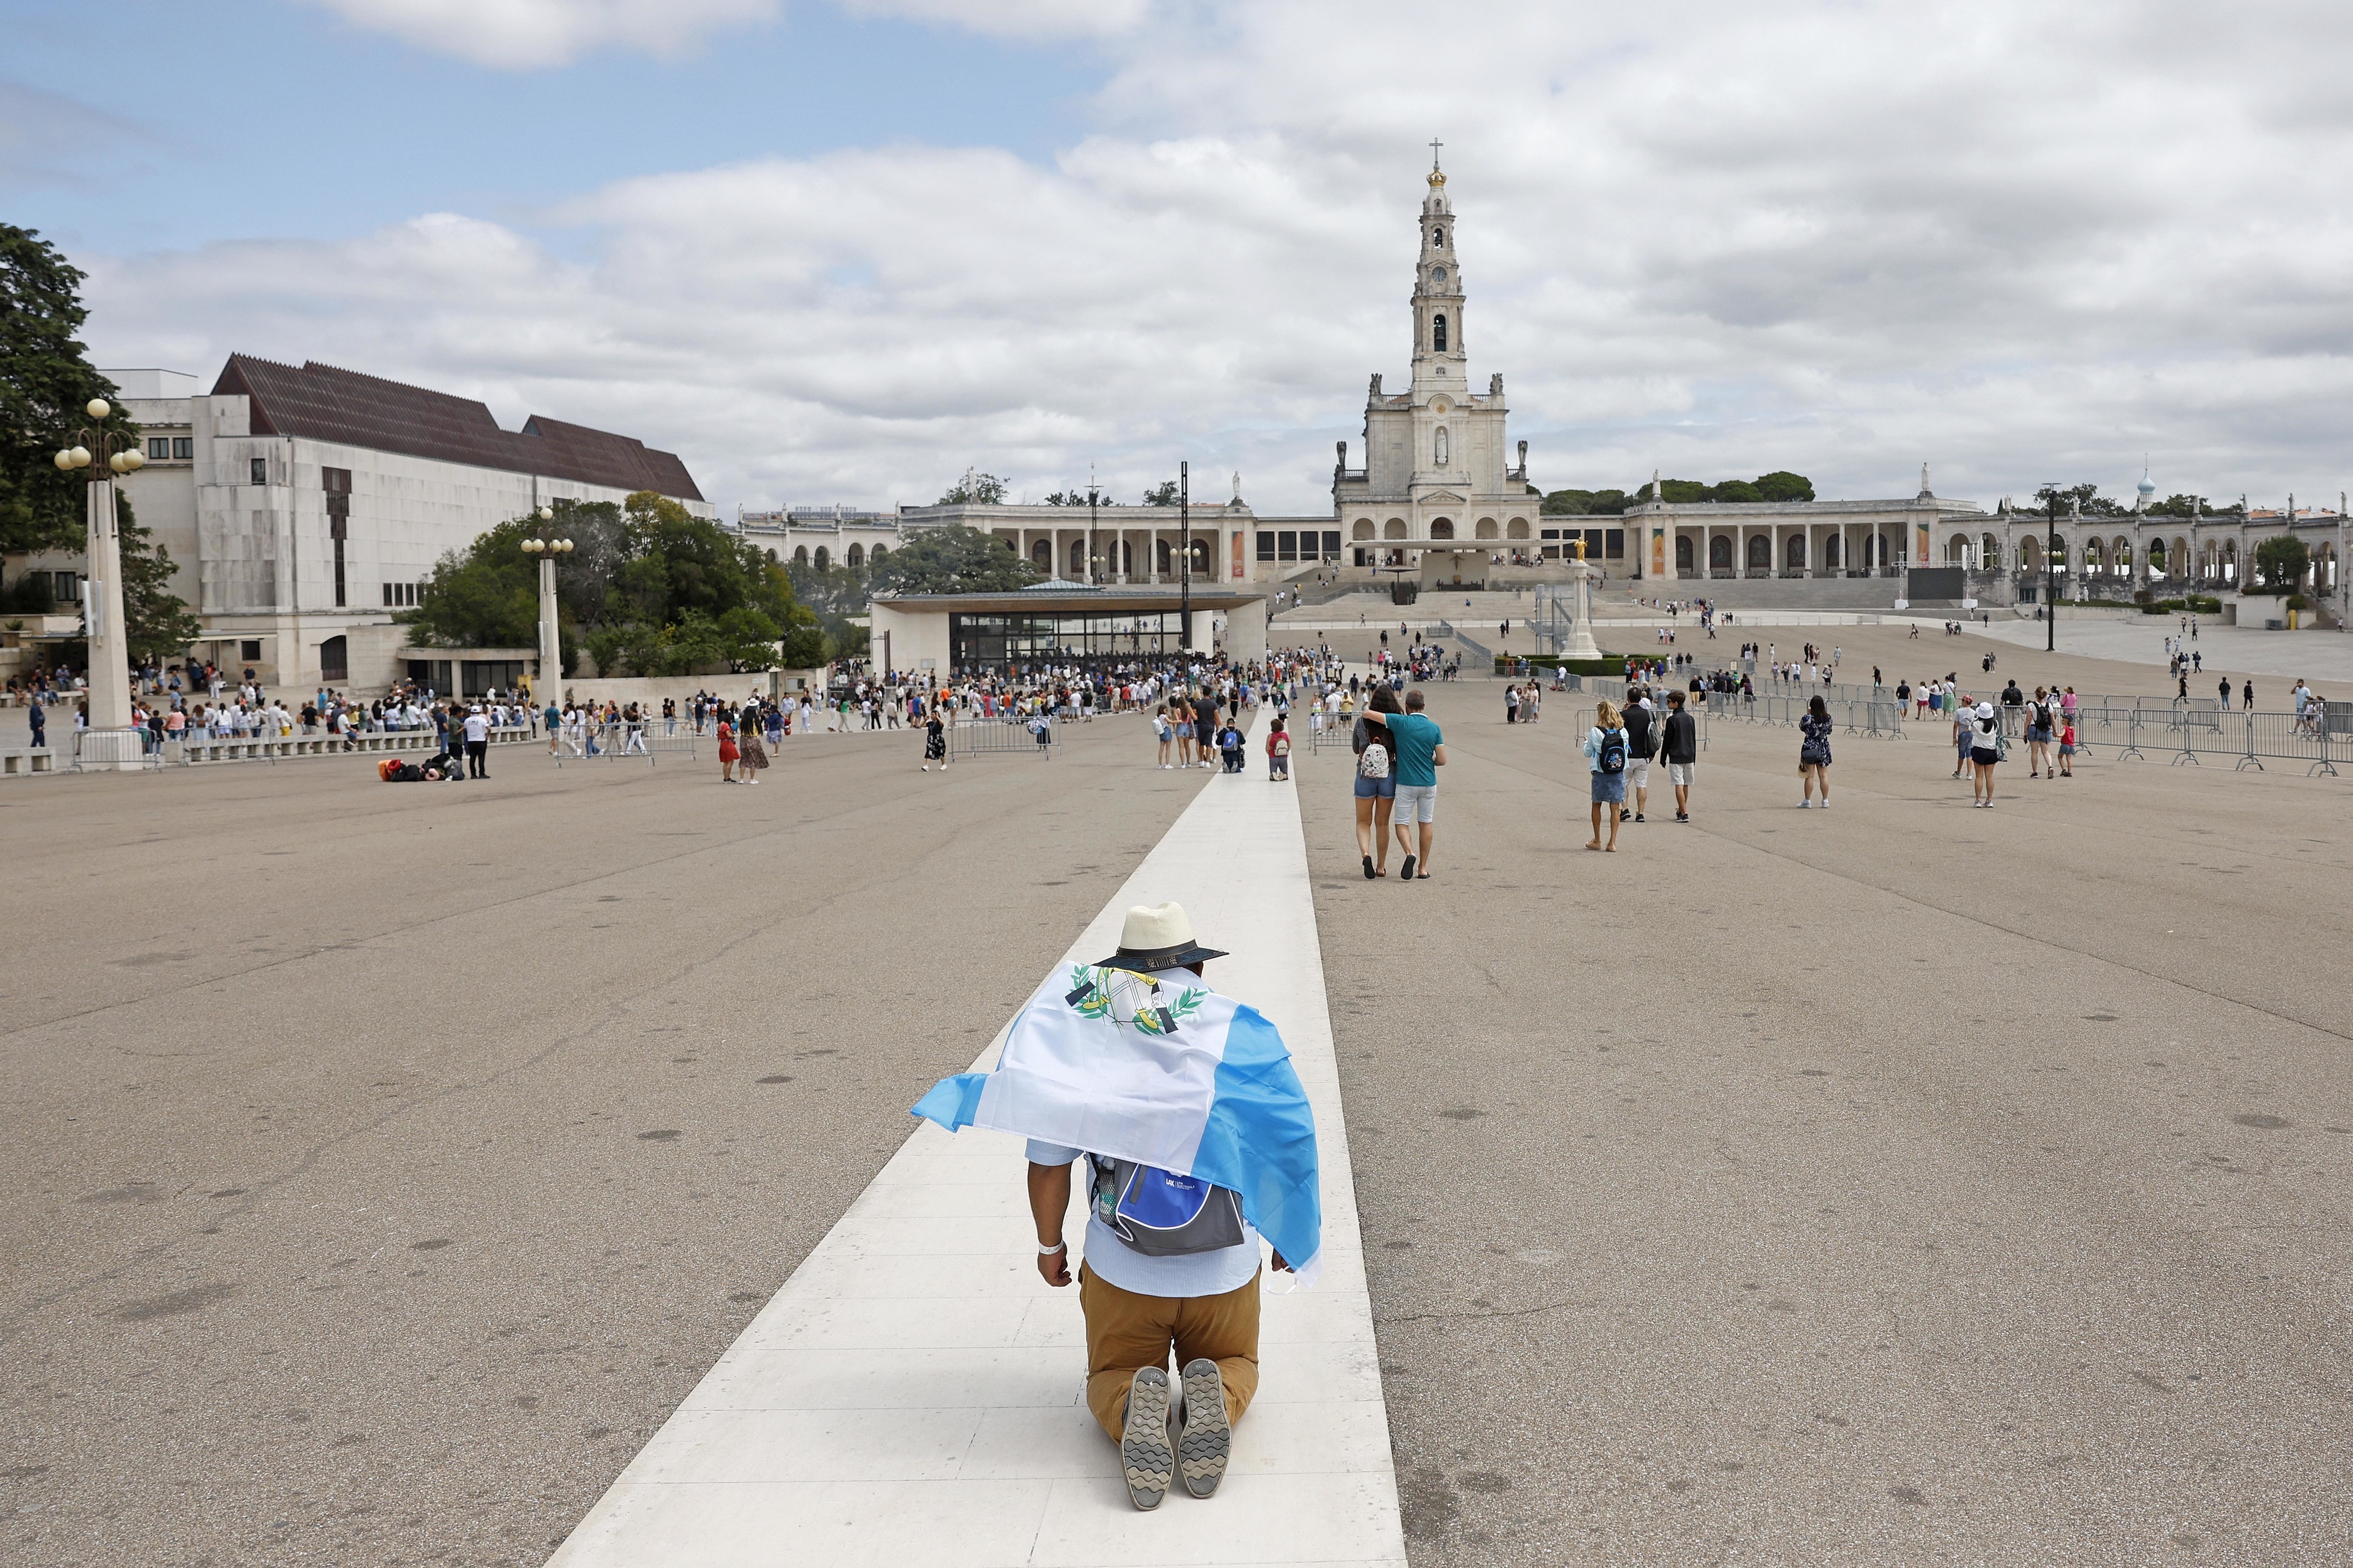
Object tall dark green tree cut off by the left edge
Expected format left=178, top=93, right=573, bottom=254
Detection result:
left=0, top=223, right=139, bottom=556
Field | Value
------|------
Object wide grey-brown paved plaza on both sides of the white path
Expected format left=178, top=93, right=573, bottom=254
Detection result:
left=0, top=629, right=2353, bottom=1566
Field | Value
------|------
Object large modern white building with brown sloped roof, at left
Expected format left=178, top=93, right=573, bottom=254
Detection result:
left=7, top=353, right=715, bottom=690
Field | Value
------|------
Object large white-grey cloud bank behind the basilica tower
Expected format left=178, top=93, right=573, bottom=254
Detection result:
left=94, top=0, right=2353, bottom=509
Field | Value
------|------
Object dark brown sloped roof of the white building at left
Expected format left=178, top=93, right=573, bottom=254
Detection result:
left=212, top=353, right=704, bottom=502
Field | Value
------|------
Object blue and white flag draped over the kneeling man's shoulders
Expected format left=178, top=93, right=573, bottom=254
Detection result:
left=915, top=963, right=1322, bottom=1283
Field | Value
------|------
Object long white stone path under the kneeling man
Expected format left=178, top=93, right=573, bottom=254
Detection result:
left=551, top=715, right=1405, bottom=1568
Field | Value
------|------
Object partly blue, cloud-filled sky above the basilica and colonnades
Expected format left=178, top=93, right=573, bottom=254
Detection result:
left=0, top=0, right=2353, bottom=511
